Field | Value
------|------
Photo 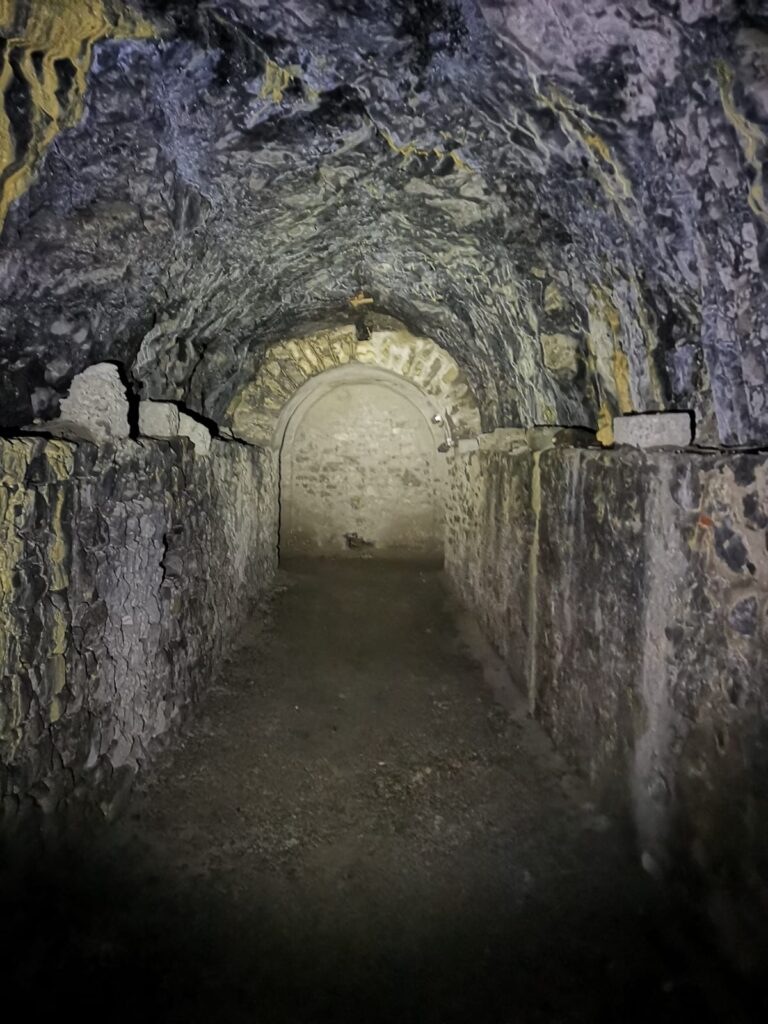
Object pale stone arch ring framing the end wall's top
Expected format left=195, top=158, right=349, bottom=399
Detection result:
left=224, top=324, right=481, bottom=447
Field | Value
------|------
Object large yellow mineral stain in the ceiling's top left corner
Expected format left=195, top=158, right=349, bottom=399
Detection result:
left=0, top=0, right=155, bottom=227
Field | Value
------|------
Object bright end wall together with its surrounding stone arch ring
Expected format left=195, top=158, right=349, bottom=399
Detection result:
left=223, top=316, right=482, bottom=562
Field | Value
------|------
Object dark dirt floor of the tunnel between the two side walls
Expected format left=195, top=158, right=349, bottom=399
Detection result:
left=3, top=561, right=761, bottom=1024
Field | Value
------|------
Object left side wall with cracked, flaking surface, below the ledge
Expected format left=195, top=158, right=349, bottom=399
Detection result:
left=0, top=437, right=276, bottom=815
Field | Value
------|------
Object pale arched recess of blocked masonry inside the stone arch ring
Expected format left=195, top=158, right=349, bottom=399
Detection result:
left=280, top=366, right=445, bottom=560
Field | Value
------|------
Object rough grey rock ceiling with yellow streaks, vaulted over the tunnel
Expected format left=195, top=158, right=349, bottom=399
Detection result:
left=0, top=0, right=768, bottom=444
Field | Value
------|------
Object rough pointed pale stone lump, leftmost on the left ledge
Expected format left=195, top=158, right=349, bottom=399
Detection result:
left=45, top=362, right=130, bottom=444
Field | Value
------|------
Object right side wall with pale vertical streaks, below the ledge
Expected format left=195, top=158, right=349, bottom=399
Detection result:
left=446, top=449, right=768, bottom=959
